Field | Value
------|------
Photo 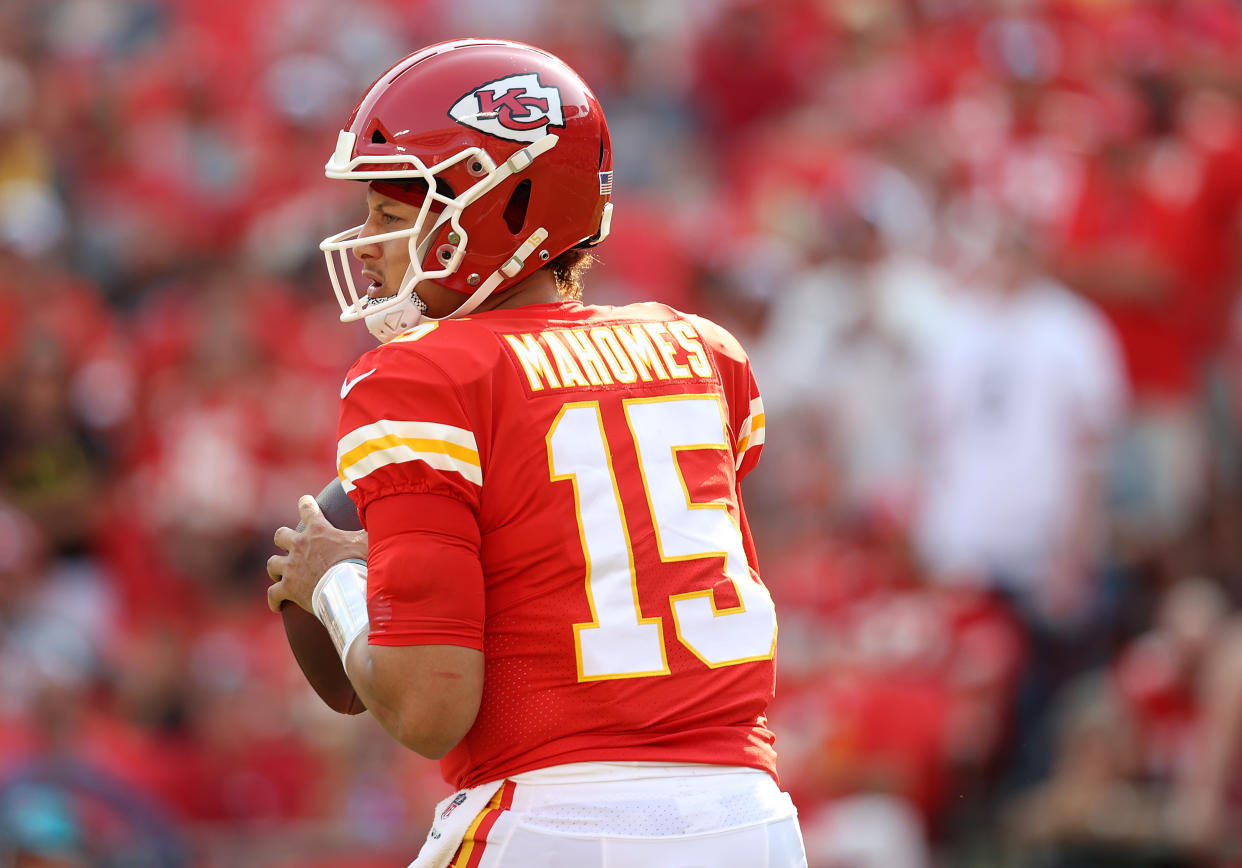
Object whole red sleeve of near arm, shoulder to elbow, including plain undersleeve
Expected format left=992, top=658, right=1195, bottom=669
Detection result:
left=337, top=345, right=484, bottom=649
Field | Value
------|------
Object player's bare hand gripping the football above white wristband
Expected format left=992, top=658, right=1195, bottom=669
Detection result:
left=267, top=494, right=368, bottom=612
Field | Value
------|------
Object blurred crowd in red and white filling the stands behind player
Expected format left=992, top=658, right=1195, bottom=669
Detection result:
left=0, top=0, right=1242, bottom=868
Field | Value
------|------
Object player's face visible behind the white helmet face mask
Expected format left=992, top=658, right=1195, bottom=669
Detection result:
left=354, top=189, right=465, bottom=317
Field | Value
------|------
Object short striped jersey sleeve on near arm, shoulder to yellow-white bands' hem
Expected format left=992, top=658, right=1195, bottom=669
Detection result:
left=337, top=348, right=483, bottom=527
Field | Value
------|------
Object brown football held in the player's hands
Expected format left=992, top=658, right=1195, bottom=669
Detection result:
left=281, top=479, right=366, bottom=714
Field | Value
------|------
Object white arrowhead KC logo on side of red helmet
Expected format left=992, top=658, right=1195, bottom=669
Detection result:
left=448, top=72, right=565, bottom=144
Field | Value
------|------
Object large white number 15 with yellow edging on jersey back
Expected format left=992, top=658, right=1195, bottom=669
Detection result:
left=548, top=395, right=776, bottom=680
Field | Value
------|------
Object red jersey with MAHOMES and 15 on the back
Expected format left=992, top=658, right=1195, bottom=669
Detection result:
left=338, top=302, right=776, bottom=787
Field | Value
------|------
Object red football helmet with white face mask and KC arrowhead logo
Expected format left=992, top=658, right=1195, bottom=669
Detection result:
left=319, top=40, right=612, bottom=340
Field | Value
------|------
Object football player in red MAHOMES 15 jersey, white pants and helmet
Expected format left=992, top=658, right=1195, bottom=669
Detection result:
left=268, top=40, right=806, bottom=868
